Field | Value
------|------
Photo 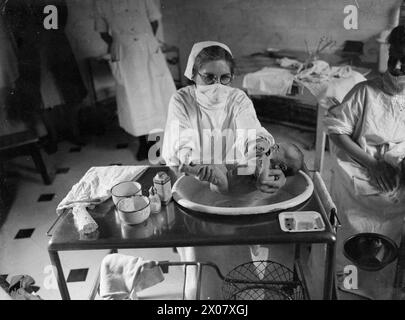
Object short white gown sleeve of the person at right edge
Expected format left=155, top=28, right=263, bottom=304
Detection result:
left=324, top=84, right=366, bottom=136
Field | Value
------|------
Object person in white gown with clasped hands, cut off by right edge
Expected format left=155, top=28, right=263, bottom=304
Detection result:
left=325, top=26, right=405, bottom=299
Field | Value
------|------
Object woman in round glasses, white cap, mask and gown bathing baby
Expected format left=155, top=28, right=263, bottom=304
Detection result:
left=162, top=41, right=285, bottom=299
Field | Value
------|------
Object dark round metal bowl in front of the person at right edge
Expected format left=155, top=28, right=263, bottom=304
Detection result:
left=343, top=233, right=398, bottom=271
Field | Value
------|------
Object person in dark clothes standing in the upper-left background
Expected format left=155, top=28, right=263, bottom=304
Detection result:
left=4, top=0, right=87, bottom=153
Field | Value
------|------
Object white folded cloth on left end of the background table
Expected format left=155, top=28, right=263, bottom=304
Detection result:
left=242, top=67, right=294, bottom=96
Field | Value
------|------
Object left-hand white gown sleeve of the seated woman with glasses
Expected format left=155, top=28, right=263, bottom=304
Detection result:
left=162, top=94, right=200, bottom=166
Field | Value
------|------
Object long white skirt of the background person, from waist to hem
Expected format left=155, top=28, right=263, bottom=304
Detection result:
left=110, top=34, right=176, bottom=136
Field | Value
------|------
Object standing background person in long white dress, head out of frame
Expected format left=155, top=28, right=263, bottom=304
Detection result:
left=94, top=0, right=176, bottom=160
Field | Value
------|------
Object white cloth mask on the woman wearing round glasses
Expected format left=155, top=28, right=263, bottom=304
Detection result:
left=195, top=83, right=232, bottom=109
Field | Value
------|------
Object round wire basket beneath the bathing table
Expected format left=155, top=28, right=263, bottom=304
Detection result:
left=222, top=261, right=305, bottom=300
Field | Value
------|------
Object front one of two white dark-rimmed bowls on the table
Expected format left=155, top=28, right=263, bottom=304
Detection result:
left=117, top=195, right=150, bottom=225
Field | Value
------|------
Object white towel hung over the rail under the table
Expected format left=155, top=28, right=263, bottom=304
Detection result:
left=100, top=253, right=164, bottom=300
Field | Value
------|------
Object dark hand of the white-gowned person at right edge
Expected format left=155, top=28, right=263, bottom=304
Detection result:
left=369, top=160, right=397, bottom=192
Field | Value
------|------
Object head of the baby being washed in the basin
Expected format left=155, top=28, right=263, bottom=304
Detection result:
left=269, top=142, right=304, bottom=177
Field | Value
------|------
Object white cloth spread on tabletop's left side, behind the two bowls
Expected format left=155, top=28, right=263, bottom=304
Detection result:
left=56, top=166, right=147, bottom=215
